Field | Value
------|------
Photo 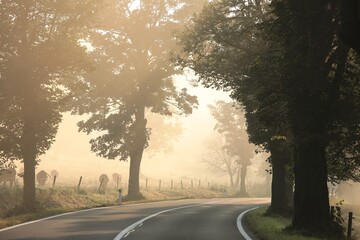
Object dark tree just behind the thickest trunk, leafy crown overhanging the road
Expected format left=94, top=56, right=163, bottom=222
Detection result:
left=180, top=1, right=292, bottom=214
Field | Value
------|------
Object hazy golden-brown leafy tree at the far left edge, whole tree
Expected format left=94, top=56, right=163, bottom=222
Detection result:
left=0, top=0, right=100, bottom=209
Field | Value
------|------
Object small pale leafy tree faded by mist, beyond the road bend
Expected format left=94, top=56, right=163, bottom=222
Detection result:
left=209, top=101, right=255, bottom=197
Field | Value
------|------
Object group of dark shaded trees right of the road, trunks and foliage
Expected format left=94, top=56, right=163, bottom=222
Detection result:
left=179, top=0, right=360, bottom=235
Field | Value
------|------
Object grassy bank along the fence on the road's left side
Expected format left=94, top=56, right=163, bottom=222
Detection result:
left=0, top=187, right=230, bottom=229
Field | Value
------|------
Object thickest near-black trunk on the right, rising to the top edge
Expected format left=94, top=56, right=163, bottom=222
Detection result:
left=278, top=0, right=336, bottom=233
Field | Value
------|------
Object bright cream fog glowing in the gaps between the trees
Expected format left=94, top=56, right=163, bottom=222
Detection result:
left=27, top=77, right=265, bottom=187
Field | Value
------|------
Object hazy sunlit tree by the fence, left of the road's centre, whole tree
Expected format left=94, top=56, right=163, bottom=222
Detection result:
left=74, top=0, right=202, bottom=199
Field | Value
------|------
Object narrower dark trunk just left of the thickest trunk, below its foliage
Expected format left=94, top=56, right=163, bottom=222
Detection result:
left=268, top=143, right=292, bottom=215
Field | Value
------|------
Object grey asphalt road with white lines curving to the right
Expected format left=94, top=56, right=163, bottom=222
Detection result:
left=0, top=198, right=269, bottom=240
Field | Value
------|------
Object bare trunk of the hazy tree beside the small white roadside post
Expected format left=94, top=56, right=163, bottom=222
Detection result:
left=128, top=106, right=147, bottom=200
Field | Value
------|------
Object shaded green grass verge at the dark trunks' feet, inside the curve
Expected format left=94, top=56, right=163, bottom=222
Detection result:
left=244, top=206, right=338, bottom=240
